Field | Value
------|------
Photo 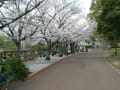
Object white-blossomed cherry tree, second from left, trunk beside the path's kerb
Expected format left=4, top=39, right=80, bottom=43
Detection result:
left=31, top=0, right=80, bottom=60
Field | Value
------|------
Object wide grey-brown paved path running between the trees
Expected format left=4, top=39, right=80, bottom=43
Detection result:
left=16, top=50, right=120, bottom=90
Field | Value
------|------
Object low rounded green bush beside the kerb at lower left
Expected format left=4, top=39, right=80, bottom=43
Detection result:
left=1, top=58, right=29, bottom=80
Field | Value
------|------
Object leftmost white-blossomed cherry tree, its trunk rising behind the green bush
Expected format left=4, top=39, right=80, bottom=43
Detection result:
left=0, top=0, right=42, bottom=57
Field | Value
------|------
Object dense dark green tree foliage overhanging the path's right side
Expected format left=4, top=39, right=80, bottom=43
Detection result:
left=90, top=0, right=120, bottom=50
